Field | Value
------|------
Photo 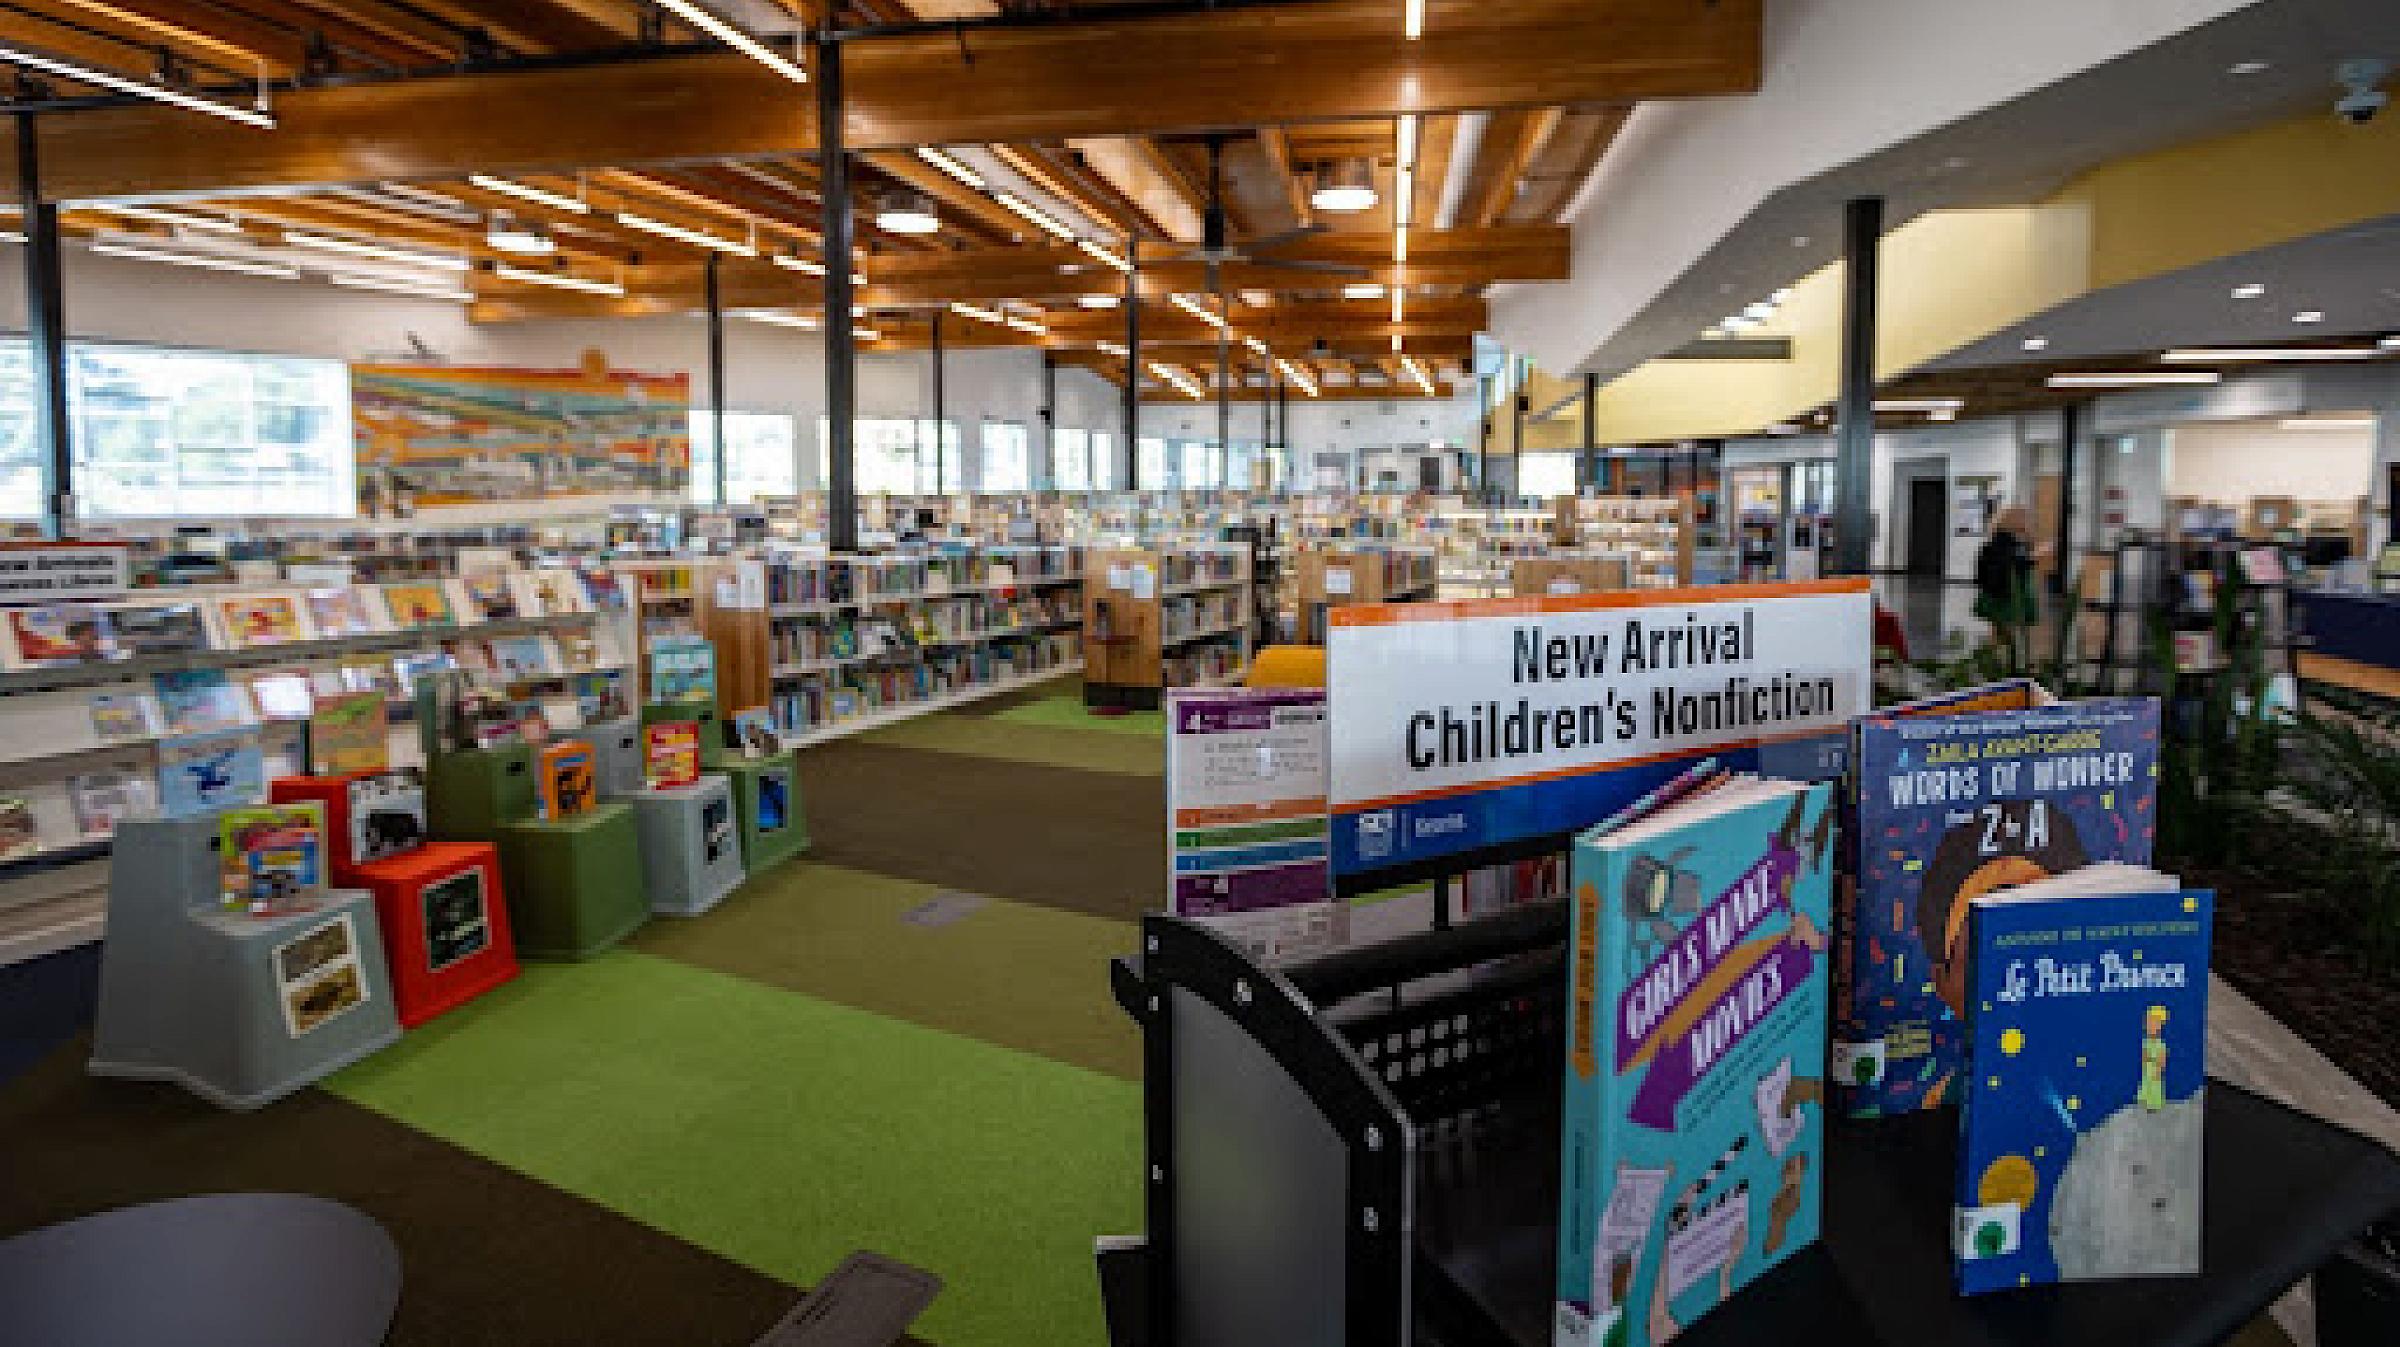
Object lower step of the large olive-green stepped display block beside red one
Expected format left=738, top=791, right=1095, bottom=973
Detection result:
left=492, top=804, right=650, bottom=958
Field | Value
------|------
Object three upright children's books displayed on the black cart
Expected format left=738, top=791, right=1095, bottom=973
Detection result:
left=1558, top=682, right=2213, bottom=1347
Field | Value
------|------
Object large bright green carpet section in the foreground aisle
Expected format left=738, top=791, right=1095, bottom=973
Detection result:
left=329, top=951, right=1142, bottom=1347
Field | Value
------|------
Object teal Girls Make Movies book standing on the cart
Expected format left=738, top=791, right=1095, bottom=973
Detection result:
left=1555, top=778, right=1834, bottom=1347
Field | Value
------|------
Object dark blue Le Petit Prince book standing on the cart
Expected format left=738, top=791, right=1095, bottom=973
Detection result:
left=1954, top=867, right=2215, bottom=1294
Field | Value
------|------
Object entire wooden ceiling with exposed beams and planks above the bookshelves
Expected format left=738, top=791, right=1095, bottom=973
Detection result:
left=0, top=0, right=1759, bottom=396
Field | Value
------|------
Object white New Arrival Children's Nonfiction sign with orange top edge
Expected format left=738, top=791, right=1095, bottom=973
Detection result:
left=1325, top=579, right=1872, bottom=876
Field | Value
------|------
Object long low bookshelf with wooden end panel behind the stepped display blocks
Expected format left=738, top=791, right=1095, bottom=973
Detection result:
left=701, top=545, right=1082, bottom=747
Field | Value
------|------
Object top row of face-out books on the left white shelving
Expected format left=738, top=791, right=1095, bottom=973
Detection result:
left=0, top=569, right=593, bottom=670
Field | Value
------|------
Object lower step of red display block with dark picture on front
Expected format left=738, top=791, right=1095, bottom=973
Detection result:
left=358, top=843, right=516, bottom=1030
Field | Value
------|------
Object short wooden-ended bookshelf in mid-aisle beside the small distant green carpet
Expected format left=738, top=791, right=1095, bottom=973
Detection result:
left=1082, top=543, right=1255, bottom=708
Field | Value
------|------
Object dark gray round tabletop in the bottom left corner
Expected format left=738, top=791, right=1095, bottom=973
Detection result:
left=0, top=1193, right=401, bottom=1347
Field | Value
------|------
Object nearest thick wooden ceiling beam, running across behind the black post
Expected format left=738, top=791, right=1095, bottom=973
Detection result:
left=0, top=0, right=1762, bottom=199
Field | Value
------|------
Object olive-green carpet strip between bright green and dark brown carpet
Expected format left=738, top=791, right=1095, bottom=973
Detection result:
left=634, top=862, right=1142, bottom=1080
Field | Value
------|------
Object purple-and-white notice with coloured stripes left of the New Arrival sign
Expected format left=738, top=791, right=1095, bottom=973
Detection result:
left=1166, top=687, right=1342, bottom=960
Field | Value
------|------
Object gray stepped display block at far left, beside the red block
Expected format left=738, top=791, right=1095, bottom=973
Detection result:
left=91, top=814, right=401, bottom=1109
